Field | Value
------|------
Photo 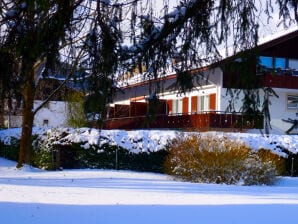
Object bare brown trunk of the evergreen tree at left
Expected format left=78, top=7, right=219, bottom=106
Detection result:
left=17, top=69, right=35, bottom=168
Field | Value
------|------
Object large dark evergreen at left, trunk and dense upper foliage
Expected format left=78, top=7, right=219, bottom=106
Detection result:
left=0, top=0, right=78, bottom=167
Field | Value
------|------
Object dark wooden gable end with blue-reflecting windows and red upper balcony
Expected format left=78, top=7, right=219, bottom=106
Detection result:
left=220, top=31, right=298, bottom=89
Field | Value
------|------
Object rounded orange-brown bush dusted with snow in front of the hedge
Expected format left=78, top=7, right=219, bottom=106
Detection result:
left=166, top=135, right=279, bottom=185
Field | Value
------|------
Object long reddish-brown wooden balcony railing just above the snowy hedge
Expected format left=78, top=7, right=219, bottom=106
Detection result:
left=104, top=112, right=263, bottom=131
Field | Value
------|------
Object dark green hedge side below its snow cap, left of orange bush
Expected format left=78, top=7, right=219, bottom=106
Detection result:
left=32, top=136, right=167, bottom=173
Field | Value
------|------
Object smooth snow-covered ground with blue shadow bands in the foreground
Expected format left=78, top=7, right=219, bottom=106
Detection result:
left=0, top=158, right=298, bottom=224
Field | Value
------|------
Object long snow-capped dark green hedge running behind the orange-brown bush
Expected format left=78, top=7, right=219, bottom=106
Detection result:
left=0, top=128, right=292, bottom=175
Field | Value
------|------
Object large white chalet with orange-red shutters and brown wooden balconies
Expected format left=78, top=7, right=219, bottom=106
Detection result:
left=105, top=30, right=298, bottom=134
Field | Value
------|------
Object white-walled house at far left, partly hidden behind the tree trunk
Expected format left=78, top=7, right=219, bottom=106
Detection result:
left=1, top=67, right=85, bottom=128
